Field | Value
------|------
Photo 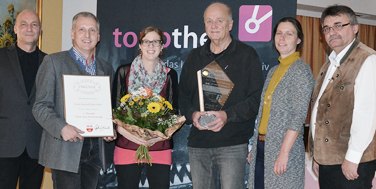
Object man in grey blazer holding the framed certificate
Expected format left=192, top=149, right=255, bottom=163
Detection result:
left=33, top=12, right=115, bottom=189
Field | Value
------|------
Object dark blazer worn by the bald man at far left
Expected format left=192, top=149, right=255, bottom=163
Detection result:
left=0, top=44, right=46, bottom=159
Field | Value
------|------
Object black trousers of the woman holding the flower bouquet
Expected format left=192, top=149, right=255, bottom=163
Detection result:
left=115, top=163, right=170, bottom=189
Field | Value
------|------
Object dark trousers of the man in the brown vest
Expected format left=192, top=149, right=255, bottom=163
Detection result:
left=319, top=160, right=376, bottom=189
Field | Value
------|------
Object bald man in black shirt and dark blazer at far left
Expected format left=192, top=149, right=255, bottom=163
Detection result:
left=0, top=10, right=46, bottom=189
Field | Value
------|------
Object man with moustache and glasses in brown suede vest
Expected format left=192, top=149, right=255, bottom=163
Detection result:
left=310, top=5, right=376, bottom=189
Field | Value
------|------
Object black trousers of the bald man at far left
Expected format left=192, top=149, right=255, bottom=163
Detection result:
left=0, top=149, right=44, bottom=189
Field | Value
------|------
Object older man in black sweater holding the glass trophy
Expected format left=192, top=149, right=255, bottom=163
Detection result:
left=179, top=3, right=263, bottom=189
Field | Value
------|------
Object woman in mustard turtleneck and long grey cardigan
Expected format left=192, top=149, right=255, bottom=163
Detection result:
left=248, top=17, right=314, bottom=189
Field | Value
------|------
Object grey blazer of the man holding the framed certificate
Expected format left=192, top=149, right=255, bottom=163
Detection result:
left=33, top=51, right=114, bottom=173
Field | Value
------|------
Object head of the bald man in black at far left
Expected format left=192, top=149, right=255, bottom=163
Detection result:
left=14, top=9, right=41, bottom=52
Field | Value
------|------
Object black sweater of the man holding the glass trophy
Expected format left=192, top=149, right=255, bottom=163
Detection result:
left=179, top=39, right=264, bottom=148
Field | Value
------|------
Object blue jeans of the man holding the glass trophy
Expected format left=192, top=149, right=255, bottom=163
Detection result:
left=188, top=144, right=248, bottom=189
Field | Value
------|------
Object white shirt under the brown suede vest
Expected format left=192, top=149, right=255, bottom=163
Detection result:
left=311, top=40, right=376, bottom=164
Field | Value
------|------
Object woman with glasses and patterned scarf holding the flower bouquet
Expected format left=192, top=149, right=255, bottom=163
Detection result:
left=112, top=26, right=178, bottom=189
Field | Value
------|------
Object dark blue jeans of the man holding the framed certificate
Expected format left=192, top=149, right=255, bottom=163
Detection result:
left=51, top=138, right=101, bottom=189
